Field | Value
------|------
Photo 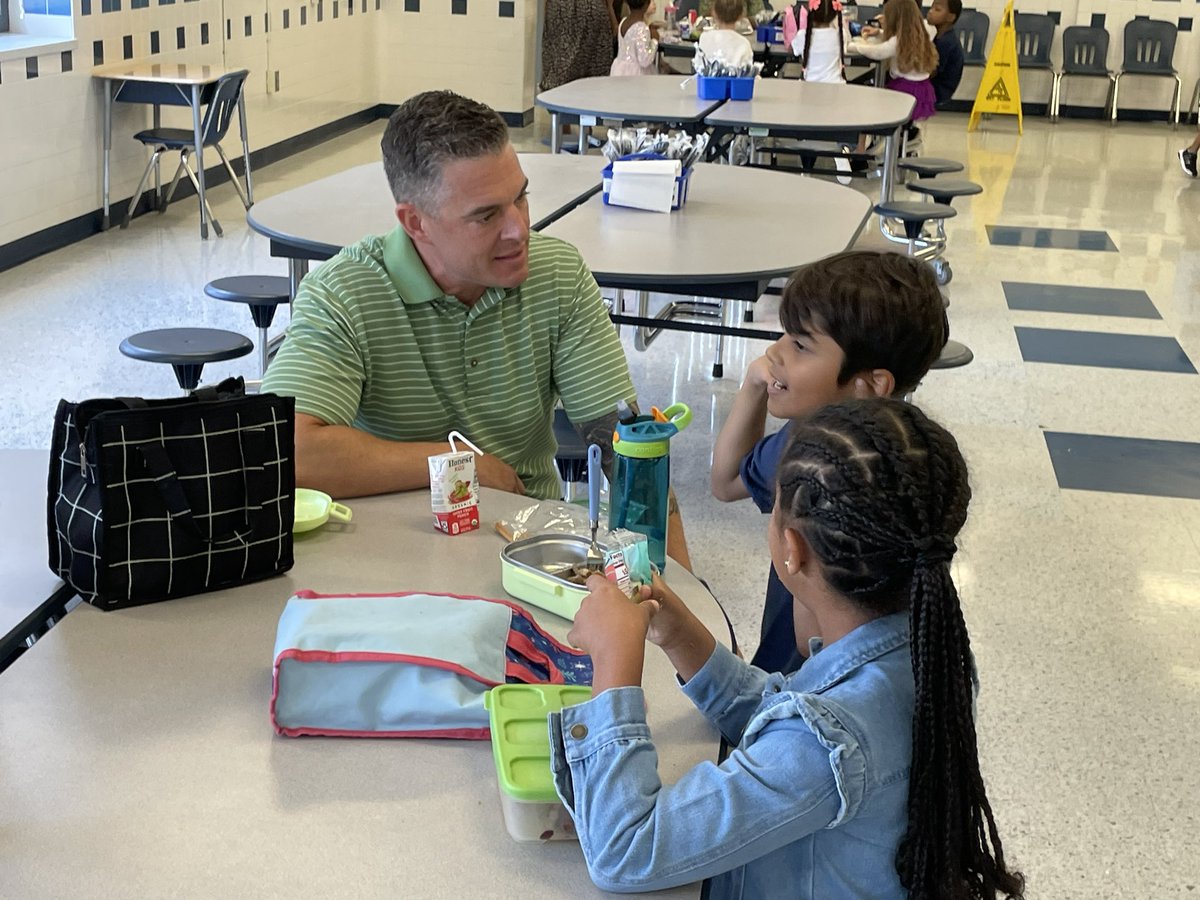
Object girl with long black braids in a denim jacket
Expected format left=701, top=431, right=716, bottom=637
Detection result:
left=550, top=398, right=1024, bottom=900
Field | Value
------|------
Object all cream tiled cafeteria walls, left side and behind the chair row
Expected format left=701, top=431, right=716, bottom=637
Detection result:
left=0, top=0, right=1185, bottom=254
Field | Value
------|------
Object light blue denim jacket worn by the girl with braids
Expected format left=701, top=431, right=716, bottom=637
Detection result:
left=550, top=613, right=913, bottom=900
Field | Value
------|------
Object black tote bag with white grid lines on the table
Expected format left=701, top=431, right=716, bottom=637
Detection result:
left=47, top=378, right=295, bottom=610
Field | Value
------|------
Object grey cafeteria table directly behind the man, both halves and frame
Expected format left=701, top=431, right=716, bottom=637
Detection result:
left=247, top=154, right=871, bottom=376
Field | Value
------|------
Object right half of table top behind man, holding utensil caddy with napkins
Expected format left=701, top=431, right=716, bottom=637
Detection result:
left=544, top=162, right=871, bottom=287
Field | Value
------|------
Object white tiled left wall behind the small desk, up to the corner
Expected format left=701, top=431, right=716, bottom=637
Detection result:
left=0, top=0, right=376, bottom=247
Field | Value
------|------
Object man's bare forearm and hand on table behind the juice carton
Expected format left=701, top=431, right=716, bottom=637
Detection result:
left=295, top=413, right=524, bottom=499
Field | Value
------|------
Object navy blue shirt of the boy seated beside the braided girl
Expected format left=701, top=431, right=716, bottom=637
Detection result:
left=738, top=427, right=804, bottom=673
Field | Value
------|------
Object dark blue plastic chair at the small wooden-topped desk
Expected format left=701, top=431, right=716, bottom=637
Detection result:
left=121, top=68, right=250, bottom=238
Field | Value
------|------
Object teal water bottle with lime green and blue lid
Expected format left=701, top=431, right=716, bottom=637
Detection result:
left=608, top=403, right=691, bottom=571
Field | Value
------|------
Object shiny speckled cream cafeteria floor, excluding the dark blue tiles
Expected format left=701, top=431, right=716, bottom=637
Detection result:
left=0, top=109, right=1200, bottom=899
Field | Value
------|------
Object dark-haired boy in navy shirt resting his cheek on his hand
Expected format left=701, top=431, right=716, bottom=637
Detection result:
left=710, top=251, right=948, bottom=673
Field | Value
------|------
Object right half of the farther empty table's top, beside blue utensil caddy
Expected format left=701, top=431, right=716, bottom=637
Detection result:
left=704, top=78, right=916, bottom=133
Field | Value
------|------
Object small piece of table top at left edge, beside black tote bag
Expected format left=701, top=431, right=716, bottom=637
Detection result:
left=0, top=450, right=61, bottom=643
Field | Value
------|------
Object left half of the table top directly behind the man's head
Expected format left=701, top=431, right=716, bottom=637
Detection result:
left=246, top=154, right=604, bottom=256
